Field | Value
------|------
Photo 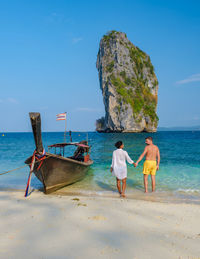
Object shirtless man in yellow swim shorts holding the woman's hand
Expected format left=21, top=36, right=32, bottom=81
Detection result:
left=135, top=137, right=160, bottom=193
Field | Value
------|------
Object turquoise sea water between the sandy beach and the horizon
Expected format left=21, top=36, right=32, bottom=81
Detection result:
left=0, top=131, right=200, bottom=204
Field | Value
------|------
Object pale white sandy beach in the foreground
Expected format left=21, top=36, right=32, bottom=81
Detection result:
left=0, top=191, right=200, bottom=259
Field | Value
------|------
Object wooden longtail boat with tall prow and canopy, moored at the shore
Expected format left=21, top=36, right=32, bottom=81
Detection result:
left=25, top=112, right=93, bottom=194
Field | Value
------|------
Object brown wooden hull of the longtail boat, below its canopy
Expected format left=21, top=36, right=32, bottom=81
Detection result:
left=25, top=153, right=93, bottom=194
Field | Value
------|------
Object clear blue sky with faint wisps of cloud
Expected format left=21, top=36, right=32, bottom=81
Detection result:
left=0, top=0, right=200, bottom=132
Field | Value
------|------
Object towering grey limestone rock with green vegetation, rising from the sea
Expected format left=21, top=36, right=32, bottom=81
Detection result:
left=96, top=31, right=158, bottom=132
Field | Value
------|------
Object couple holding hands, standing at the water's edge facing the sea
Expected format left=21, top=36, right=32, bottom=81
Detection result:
left=110, top=137, right=160, bottom=197
